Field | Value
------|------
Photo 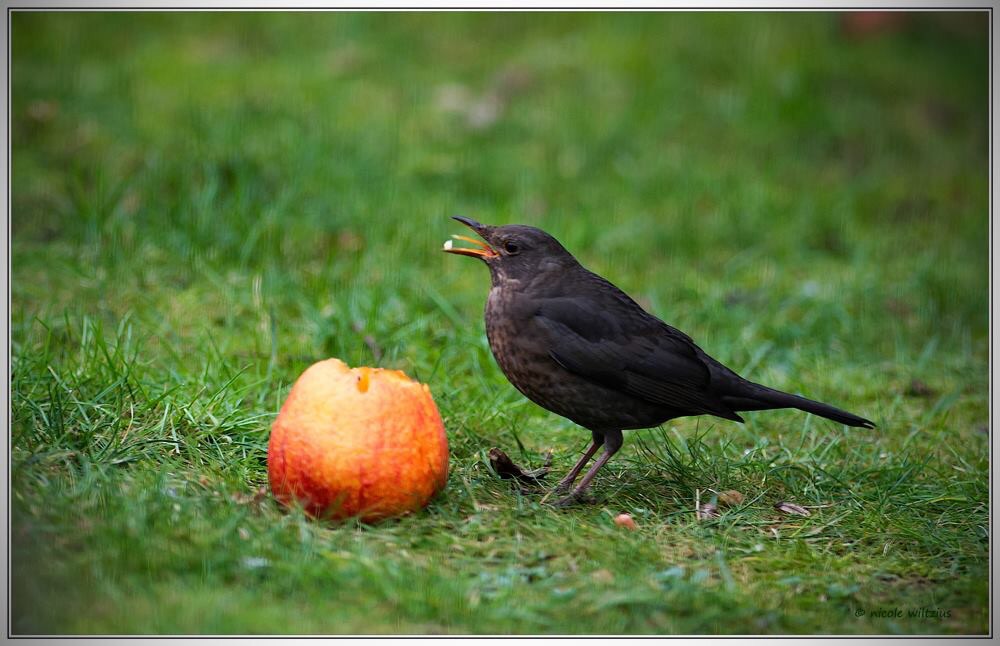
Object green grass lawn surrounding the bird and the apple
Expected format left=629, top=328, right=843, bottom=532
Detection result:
left=11, top=12, right=990, bottom=634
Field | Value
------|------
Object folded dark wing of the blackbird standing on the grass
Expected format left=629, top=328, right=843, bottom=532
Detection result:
left=535, top=298, right=742, bottom=421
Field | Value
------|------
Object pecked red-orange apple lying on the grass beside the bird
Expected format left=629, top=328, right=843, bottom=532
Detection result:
left=267, top=359, right=448, bottom=522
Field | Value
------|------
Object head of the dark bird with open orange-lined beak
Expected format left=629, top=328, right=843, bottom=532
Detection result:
left=444, top=216, right=579, bottom=284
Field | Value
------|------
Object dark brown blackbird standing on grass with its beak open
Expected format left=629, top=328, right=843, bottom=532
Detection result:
left=444, top=217, right=875, bottom=506
